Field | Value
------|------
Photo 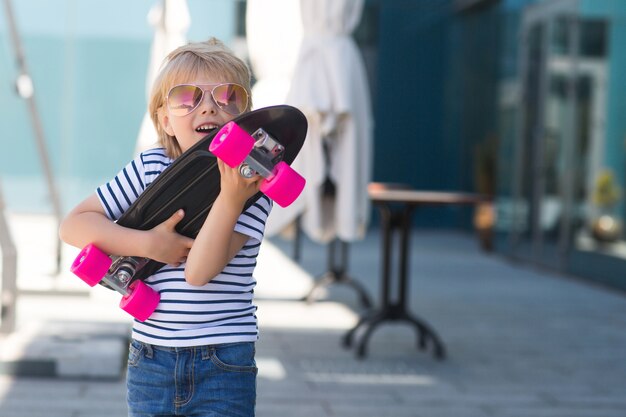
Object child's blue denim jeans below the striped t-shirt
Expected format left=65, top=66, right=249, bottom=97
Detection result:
left=126, top=340, right=257, bottom=417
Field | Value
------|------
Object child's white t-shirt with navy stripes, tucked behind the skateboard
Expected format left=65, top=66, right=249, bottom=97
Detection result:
left=96, top=148, right=272, bottom=347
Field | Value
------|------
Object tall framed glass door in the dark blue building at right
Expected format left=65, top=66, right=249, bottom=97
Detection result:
left=510, top=1, right=606, bottom=269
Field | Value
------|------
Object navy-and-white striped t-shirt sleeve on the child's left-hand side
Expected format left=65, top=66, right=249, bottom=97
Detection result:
left=96, top=151, right=146, bottom=221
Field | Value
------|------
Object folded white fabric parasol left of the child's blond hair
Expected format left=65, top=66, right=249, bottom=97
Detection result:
left=135, top=0, right=191, bottom=153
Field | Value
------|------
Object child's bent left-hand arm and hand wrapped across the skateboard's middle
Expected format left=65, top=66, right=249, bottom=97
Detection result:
left=59, top=194, right=193, bottom=264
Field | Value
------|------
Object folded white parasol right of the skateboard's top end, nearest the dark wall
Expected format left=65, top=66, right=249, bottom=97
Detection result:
left=268, top=0, right=373, bottom=243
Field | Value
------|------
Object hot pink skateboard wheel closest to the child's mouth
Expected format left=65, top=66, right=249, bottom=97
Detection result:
left=209, top=122, right=254, bottom=168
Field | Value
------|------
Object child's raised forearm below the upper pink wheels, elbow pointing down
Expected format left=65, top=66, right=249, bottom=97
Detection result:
left=185, top=160, right=261, bottom=285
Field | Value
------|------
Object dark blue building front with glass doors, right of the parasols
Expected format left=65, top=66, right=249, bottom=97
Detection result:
left=366, top=0, right=626, bottom=289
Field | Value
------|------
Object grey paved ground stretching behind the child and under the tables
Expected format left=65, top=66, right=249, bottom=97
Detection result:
left=0, top=216, right=626, bottom=417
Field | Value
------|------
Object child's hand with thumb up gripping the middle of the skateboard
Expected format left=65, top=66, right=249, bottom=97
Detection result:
left=149, top=210, right=193, bottom=266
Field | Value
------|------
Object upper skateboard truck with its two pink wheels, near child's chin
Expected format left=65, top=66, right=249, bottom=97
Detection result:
left=209, top=121, right=306, bottom=207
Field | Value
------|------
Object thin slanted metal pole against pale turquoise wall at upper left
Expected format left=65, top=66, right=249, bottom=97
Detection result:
left=4, top=0, right=62, bottom=274
